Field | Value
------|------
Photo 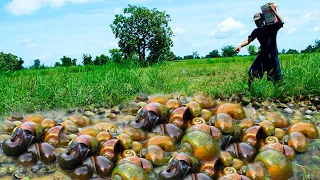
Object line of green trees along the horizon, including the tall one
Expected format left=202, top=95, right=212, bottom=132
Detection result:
left=0, top=2, right=320, bottom=72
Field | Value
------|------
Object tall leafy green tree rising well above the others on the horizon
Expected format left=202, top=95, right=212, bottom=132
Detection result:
left=110, top=5, right=173, bottom=63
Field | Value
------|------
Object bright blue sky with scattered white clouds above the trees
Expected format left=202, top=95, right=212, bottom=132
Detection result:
left=0, top=0, right=320, bottom=66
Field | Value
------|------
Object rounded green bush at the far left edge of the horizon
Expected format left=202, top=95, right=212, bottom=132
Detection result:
left=0, top=52, right=24, bottom=72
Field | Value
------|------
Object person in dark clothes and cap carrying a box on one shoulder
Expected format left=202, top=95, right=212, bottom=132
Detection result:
left=235, top=3, right=284, bottom=91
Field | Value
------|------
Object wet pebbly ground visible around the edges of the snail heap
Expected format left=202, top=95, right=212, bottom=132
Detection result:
left=0, top=95, right=320, bottom=180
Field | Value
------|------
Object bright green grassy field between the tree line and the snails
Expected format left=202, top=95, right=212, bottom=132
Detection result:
left=0, top=54, right=320, bottom=115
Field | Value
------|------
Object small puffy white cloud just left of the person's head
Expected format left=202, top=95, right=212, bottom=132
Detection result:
left=209, top=17, right=247, bottom=39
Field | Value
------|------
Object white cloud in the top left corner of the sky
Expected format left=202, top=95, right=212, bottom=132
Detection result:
left=5, top=0, right=99, bottom=15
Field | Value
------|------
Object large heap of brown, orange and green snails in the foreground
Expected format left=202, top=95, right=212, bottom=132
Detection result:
left=2, top=95, right=319, bottom=180
